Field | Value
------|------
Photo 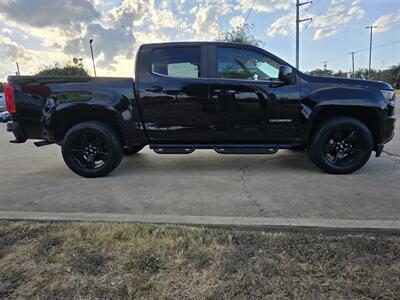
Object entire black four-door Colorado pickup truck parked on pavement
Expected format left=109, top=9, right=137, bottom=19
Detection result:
left=5, top=42, right=396, bottom=177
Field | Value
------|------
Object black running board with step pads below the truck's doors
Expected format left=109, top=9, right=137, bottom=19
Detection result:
left=150, top=144, right=282, bottom=154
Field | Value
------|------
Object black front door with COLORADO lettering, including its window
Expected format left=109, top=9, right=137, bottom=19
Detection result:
left=209, top=44, right=300, bottom=143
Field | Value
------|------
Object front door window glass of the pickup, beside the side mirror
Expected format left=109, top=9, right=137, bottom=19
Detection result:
left=218, top=48, right=280, bottom=80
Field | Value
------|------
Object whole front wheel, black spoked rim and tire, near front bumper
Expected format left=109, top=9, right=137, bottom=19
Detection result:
left=308, top=117, right=373, bottom=174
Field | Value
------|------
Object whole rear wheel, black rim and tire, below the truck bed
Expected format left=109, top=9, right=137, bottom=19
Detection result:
left=61, top=121, right=123, bottom=178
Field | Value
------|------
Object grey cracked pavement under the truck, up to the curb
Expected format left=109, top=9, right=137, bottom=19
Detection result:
left=0, top=117, right=400, bottom=220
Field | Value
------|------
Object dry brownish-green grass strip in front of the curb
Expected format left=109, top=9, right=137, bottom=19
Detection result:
left=0, top=222, right=400, bottom=299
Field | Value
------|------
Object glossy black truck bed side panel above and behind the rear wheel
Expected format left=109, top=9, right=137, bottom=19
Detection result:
left=8, top=76, right=134, bottom=139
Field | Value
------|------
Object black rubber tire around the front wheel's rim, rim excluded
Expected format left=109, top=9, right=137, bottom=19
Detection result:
left=309, top=117, right=373, bottom=174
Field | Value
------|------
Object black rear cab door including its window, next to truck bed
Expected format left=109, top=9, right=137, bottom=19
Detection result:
left=136, top=44, right=210, bottom=143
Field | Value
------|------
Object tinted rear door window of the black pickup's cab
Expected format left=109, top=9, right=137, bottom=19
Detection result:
left=151, top=47, right=201, bottom=78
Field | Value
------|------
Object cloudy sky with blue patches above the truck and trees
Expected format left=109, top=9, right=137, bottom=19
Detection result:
left=0, top=0, right=400, bottom=80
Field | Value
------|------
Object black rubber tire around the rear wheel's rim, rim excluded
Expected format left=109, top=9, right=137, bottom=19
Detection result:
left=62, top=122, right=122, bottom=178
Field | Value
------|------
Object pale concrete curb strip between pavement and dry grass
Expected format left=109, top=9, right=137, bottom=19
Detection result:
left=0, top=211, right=400, bottom=233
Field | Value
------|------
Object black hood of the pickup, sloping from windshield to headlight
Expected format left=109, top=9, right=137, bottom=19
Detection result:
left=304, top=75, right=393, bottom=90
